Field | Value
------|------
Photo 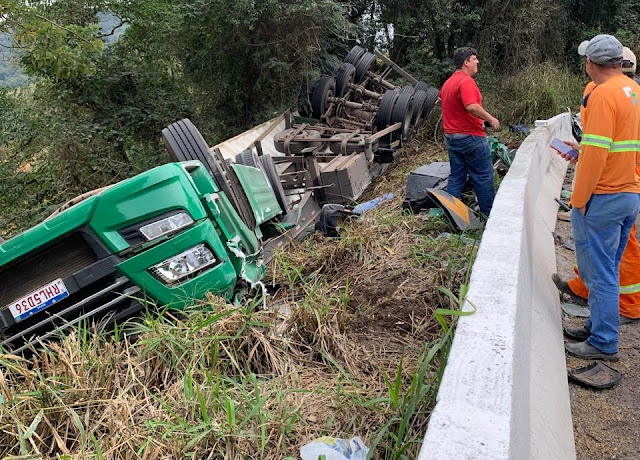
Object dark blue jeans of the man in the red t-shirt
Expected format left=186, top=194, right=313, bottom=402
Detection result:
left=445, top=134, right=495, bottom=216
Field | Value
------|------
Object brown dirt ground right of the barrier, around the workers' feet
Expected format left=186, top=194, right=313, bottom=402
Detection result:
left=555, top=164, right=640, bottom=460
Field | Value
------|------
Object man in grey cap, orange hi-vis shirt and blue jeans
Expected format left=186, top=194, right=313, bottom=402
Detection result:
left=565, top=35, right=640, bottom=360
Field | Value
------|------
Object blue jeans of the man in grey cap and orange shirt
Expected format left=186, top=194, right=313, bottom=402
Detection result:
left=571, top=193, right=640, bottom=353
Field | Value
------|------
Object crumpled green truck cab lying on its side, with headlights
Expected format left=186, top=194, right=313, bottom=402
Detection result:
left=0, top=161, right=282, bottom=352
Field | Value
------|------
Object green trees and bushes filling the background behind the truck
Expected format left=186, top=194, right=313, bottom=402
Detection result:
left=6, top=0, right=640, bottom=236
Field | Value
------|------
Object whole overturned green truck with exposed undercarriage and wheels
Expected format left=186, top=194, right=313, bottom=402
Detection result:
left=0, top=47, right=437, bottom=353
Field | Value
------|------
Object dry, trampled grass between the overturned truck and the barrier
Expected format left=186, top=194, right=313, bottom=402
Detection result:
left=0, top=137, right=474, bottom=459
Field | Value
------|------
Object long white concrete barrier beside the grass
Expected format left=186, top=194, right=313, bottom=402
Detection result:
left=419, top=113, right=576, bottom=460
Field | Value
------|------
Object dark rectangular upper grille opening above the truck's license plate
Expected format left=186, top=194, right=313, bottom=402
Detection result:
left=0, top=232, right=98, bottom=311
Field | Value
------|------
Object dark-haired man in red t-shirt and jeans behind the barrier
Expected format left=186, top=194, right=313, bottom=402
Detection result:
left=440, top=47, right=500, bottom=216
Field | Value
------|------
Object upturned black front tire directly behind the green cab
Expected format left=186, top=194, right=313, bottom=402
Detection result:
left=162, top=118, right=256, bottom=229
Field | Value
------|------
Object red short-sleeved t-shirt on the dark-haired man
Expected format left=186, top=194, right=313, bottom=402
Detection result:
left=440, top=70, right=487, bottom=137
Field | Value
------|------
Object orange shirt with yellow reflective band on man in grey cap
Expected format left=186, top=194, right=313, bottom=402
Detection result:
left=571, top=74, right=640, bottom=208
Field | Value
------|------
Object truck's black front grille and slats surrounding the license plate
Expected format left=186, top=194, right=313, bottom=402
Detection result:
left=0, top=232, right=142, bottom=353
